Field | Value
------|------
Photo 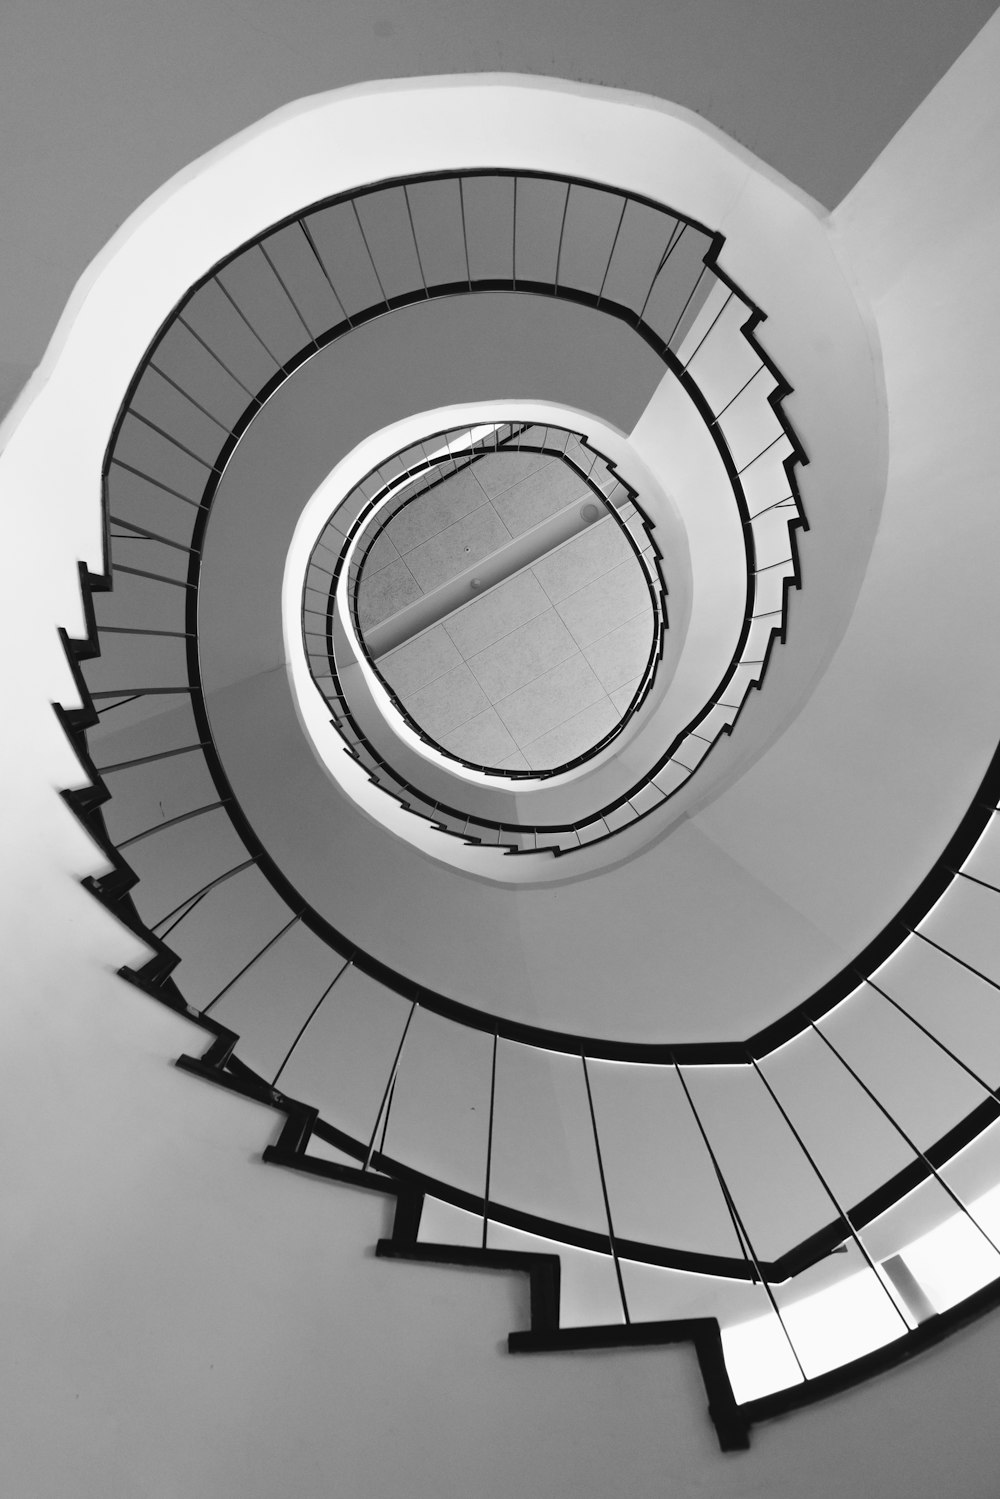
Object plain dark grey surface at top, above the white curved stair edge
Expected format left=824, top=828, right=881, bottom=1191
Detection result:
left=0, top=0, right=994, bottom=431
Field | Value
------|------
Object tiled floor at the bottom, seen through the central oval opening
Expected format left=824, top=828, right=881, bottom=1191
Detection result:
left=349, top=427, right=661, bottom=775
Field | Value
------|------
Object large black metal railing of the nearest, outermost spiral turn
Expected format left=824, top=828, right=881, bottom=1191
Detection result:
left=54, top=161, right=1000, bottom=1439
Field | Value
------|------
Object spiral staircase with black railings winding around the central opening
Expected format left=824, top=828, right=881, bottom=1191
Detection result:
left=9, top=52, right=1000, bottom=1493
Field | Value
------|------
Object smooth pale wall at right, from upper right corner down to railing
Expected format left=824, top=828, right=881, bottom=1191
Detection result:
left=697, top=2, right=1000, bottom=959
